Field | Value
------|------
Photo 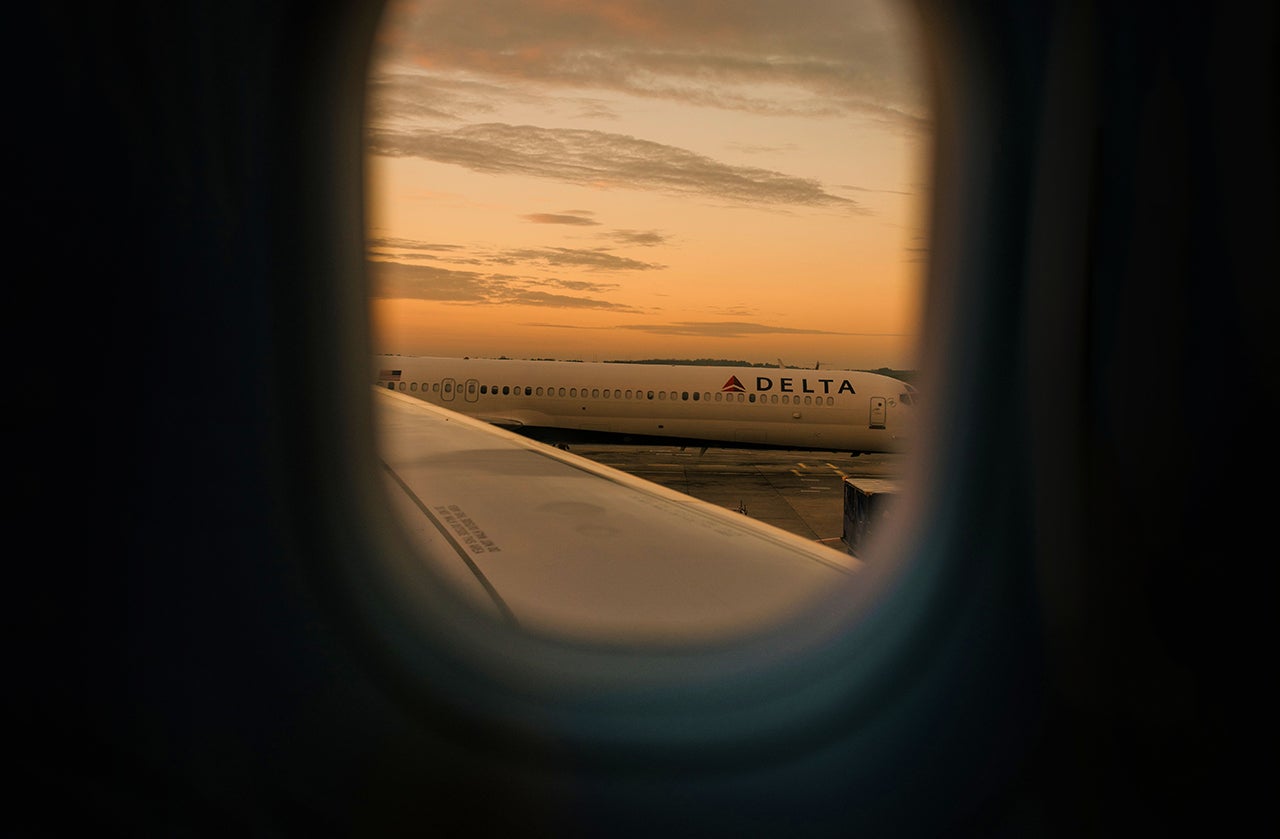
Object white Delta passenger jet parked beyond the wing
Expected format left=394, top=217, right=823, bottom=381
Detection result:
left=372, top=356, right=916, bottom=455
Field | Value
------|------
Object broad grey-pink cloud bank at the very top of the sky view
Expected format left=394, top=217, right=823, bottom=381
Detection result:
left=379, top=0, right=927, bottom=126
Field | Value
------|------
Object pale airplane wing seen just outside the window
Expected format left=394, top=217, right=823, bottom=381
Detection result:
left=374, top=388, right=860, bottom=644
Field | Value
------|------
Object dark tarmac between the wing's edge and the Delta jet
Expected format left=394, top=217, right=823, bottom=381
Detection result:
left=570, top=444, right=905, bottom=551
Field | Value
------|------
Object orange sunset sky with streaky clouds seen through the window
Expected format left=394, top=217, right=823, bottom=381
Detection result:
left=366, top=0, right=932, bottom=369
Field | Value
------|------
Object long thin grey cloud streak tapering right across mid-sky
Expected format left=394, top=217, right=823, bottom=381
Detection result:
left=369, top=123, right=865, bottom=213
